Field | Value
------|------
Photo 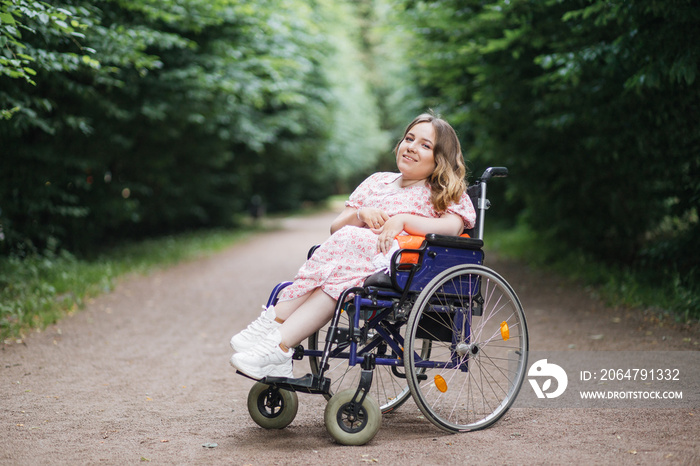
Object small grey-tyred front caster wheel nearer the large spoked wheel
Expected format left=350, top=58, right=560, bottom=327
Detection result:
left=323, top=388, right=382, bottom=445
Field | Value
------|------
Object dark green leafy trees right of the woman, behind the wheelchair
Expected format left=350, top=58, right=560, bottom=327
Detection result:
left=406, top=0, right=700, bottom=314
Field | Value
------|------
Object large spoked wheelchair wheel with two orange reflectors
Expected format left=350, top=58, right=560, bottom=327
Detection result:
left=404, top=265, right=528, bottom=432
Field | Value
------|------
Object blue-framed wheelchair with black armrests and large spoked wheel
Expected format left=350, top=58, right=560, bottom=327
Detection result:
left=238, top=167, right=528, bottom=445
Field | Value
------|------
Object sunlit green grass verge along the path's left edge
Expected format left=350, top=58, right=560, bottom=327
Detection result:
left=0, top=228, right=254, bottom=343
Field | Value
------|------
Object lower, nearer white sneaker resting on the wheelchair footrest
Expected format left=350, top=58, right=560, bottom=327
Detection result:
left=230, top=329, right=294, bottom=380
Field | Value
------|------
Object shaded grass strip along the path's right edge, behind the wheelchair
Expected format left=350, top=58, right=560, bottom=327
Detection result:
left=484, top=222, right=700, bottom=324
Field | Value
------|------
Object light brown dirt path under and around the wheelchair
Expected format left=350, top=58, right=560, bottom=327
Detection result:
left=0, top=214, right=700, bottom=465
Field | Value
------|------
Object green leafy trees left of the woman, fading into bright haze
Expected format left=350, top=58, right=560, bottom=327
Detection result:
left=0, top=0, right=388, bottom=255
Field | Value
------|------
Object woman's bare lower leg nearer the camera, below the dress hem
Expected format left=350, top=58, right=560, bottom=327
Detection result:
left=275, top=288, right=336, bottom=348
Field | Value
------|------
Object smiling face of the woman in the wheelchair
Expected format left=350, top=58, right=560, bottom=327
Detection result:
left=396, top=121, right=435, bottom=181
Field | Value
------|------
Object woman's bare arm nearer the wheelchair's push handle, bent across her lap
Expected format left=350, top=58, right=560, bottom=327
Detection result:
left=372, top=214, right=464, bottom=254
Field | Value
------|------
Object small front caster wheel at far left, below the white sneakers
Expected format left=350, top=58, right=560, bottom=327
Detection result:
left=248, top=382, right=299, bottom=429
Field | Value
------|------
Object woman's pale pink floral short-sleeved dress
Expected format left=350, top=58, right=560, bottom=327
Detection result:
left=279, top=173, right=476, bottom=301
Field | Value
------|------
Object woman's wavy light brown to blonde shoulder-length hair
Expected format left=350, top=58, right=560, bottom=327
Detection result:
left=394, top=113, right=467, bottom=213
